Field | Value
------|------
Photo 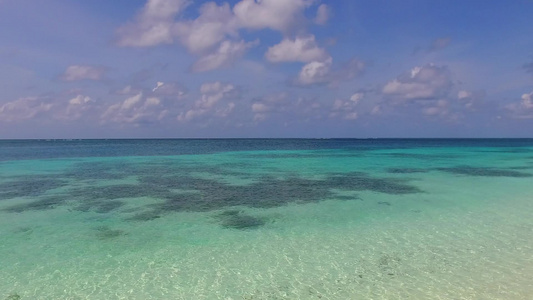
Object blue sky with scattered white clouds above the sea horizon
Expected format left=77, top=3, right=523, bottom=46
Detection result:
left=0, top=0, right=533, bottom=139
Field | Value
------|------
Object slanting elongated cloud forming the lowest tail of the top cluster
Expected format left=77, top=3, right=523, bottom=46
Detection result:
left=192, top=41, right=258, bottom=72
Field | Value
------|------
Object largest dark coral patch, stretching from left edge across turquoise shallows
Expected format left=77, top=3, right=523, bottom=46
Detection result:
left=2, top=161, right=421, bottom=221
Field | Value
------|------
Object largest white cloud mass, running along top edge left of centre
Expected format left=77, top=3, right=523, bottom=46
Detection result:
left=117, top=0, right=325, bottom=72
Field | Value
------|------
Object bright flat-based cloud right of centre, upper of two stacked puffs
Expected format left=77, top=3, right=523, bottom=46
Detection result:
left=265, top=35, right=329, bottom=62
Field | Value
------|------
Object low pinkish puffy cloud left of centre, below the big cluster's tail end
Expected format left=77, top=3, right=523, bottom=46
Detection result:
left=177, top=81, right=238, bottom=122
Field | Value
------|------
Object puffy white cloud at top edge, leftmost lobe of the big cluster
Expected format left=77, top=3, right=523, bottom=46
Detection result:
left=117, top=0, right=189, bottom=47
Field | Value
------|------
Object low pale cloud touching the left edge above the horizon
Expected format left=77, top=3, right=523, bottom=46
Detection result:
left=0, top=97, right=53, bottom=122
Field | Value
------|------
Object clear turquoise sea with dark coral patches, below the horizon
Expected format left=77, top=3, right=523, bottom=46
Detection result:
left=0, top=139, right=533, bottom=300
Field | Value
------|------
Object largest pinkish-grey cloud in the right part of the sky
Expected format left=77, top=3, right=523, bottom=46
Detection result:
left=382, top=64, right=453, bottom=100
